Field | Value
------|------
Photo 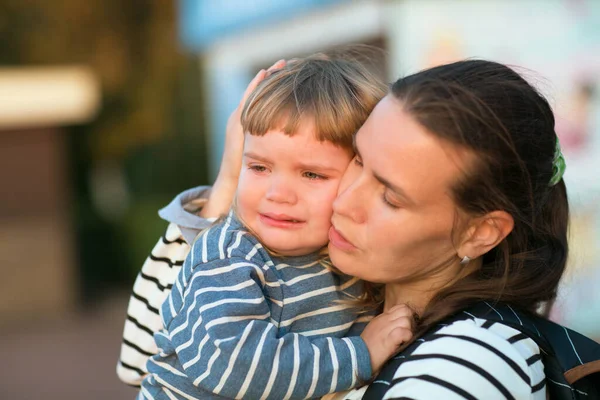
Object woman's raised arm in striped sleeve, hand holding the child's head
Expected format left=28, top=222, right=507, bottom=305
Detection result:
left=117, top=60, right=285, bottom=387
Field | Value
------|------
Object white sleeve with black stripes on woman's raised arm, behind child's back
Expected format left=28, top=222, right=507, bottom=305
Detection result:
left=117, top=224, right=190, bottom=387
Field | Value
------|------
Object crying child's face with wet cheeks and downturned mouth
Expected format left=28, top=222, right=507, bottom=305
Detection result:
left=237, top=124, right=352, bottom=256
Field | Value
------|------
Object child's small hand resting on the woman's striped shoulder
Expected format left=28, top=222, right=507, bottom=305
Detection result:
left=360, top=305, right=414, bottom=375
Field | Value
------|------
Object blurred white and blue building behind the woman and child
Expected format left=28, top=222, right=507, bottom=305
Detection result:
left=180, top=0, right=600, bottom=339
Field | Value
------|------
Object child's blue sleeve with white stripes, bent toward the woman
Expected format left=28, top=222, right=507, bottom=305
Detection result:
left=163, top=253, right=371, bottom=399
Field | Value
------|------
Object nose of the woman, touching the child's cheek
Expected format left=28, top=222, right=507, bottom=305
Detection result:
left=333, top=175, right=368, bottom=224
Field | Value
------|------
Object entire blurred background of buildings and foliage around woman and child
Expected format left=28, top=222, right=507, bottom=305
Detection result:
left=0, top=0, right=600, bottom=399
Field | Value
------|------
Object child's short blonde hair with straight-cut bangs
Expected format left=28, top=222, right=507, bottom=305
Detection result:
left=241, top=53, right=387, bottom=151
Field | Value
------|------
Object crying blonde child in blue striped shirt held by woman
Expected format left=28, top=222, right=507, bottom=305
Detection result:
left=126, top=56, right=410, bottom=399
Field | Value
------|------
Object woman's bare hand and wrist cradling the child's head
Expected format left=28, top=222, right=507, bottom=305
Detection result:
left=200, top=60, right=285, bottom=218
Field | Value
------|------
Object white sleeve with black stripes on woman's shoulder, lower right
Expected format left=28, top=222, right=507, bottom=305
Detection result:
left=382, top=321, right=545, bottom=400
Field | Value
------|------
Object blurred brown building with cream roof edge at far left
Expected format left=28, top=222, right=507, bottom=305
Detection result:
left=0, top=67, right=99, bottom=323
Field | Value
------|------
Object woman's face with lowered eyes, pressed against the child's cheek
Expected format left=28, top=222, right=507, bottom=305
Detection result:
left=329, top=96, right=467, bottom=283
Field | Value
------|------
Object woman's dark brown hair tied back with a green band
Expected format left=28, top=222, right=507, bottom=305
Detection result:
left=391, top=60, right=569, bottom=337
